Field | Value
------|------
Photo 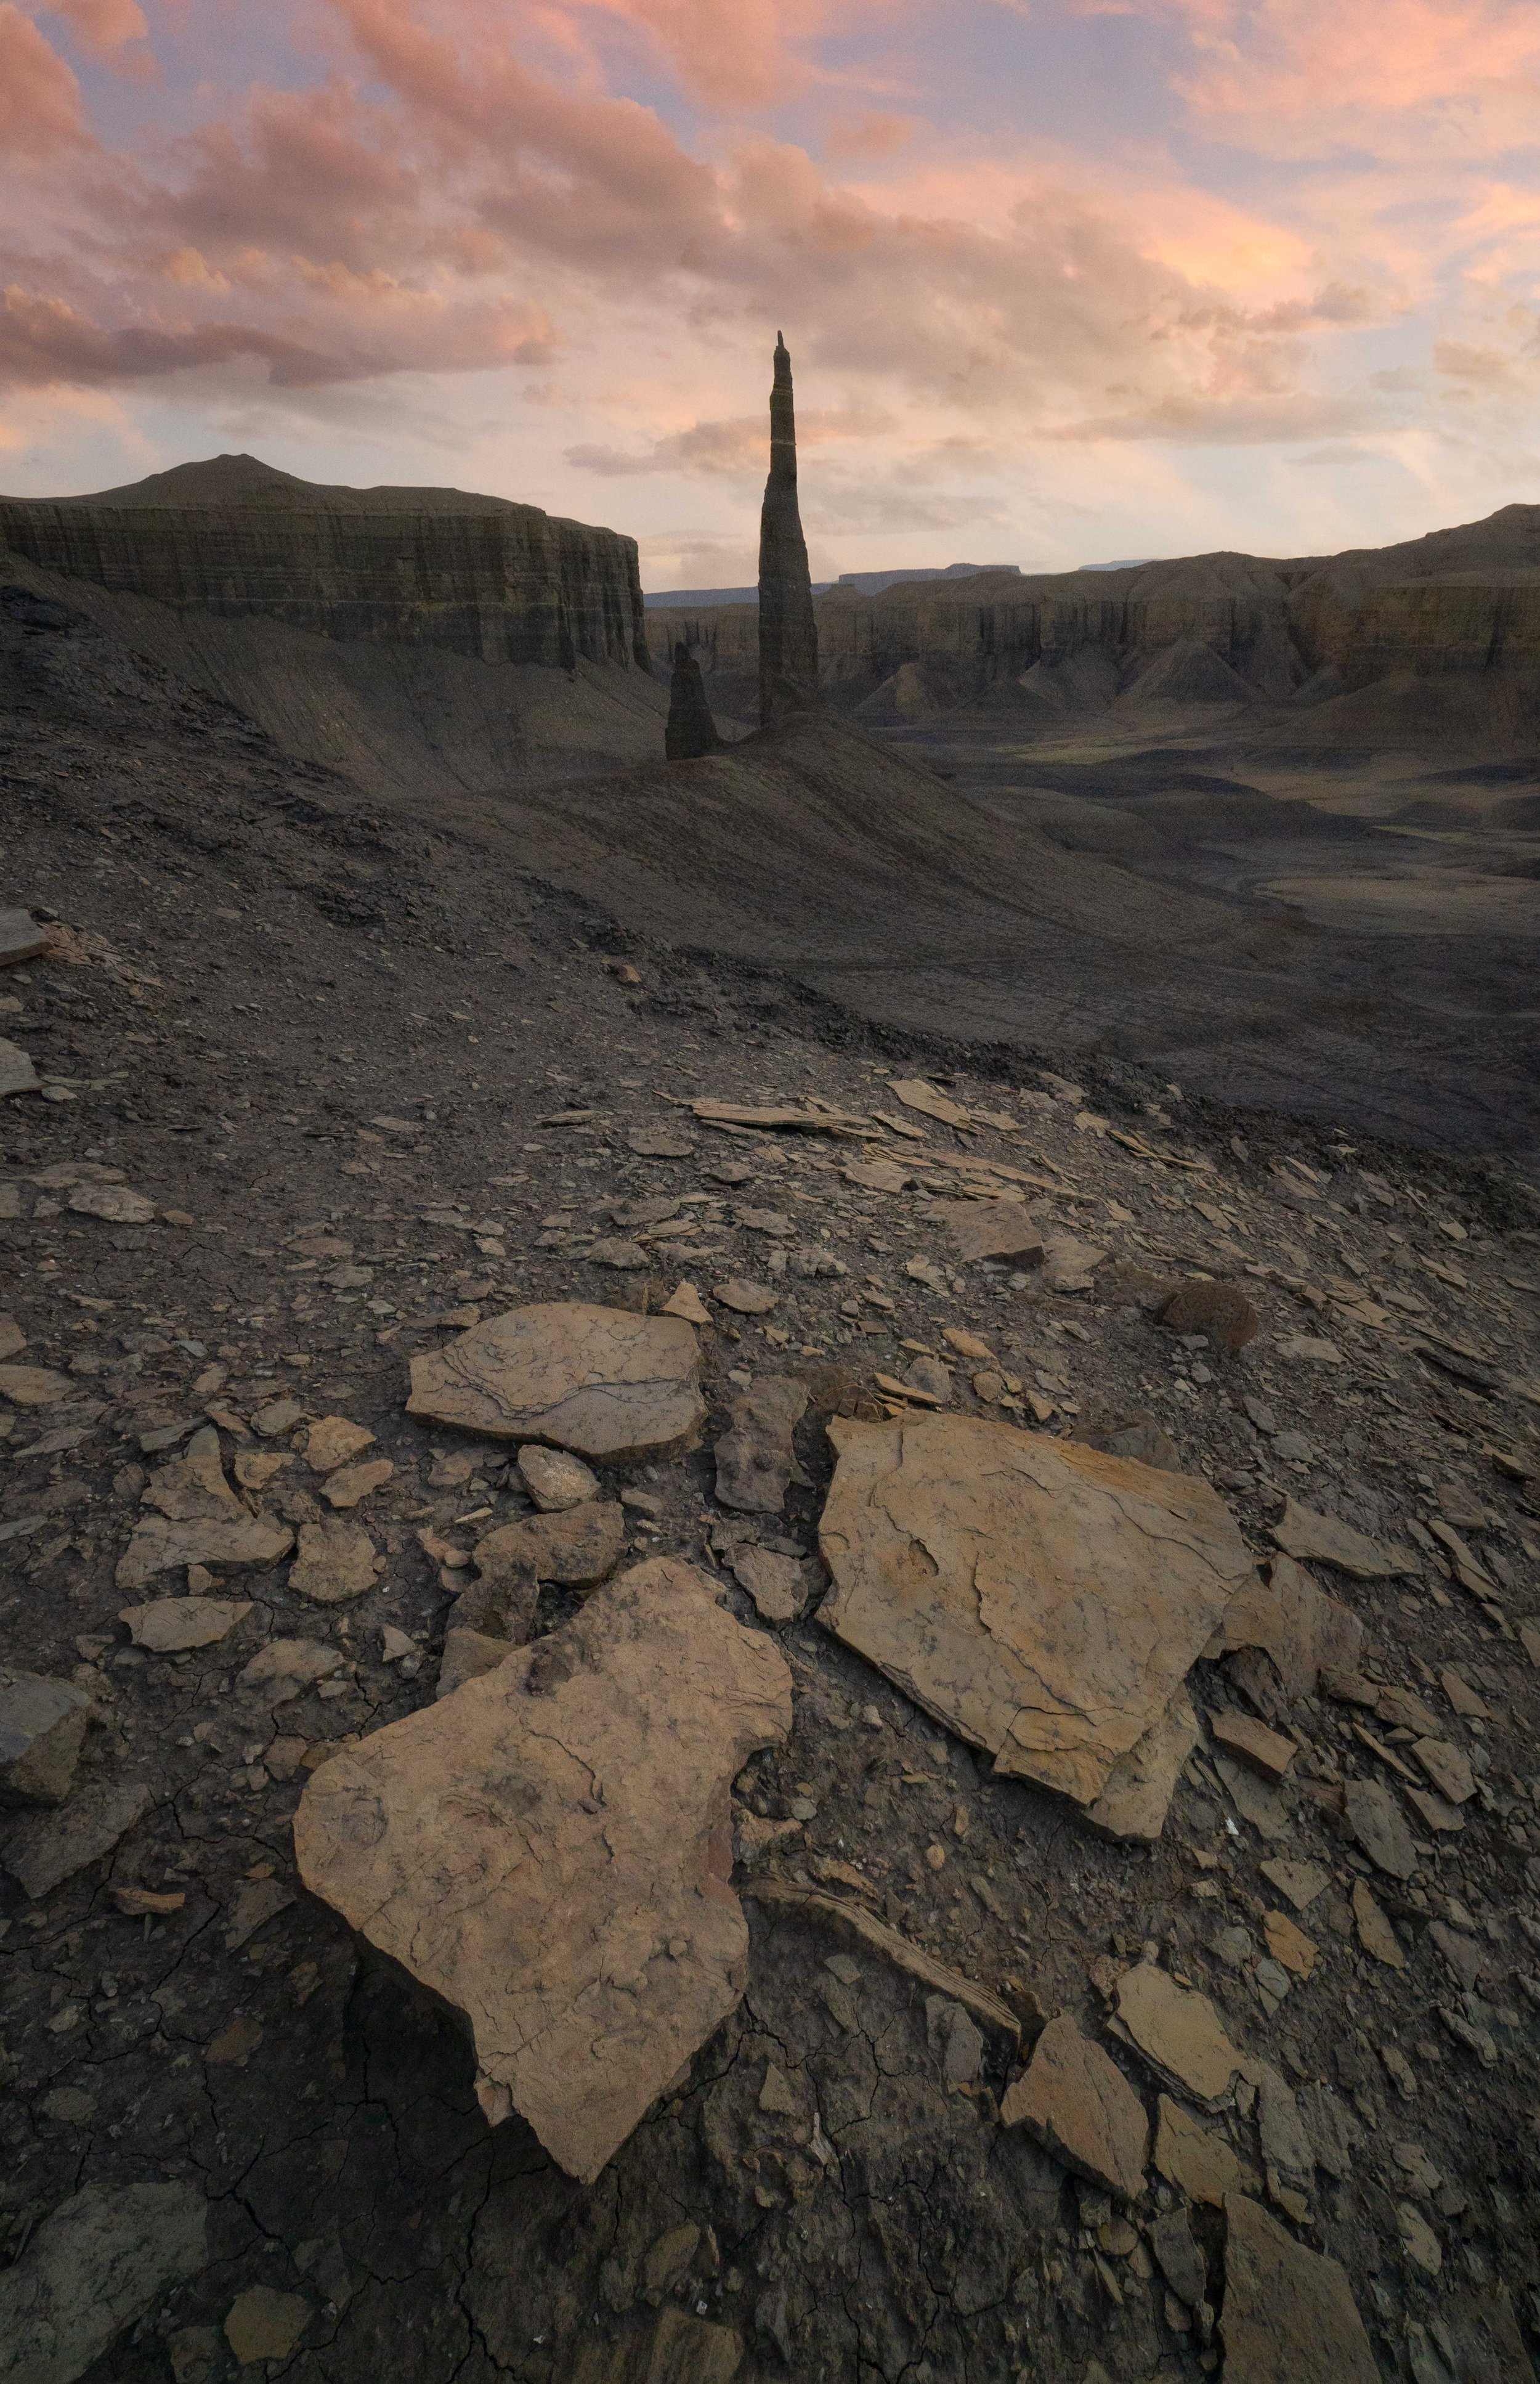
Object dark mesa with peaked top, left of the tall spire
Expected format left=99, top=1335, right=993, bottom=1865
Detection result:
left=0, top=455, right=649, bottom=670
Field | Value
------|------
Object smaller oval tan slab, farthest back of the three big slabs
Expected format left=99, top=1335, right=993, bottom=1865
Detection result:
left=408, top=1300, right=706, bottom=1464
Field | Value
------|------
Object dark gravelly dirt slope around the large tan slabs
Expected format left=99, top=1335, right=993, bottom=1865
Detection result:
left=0, top=582, right=1540, bottom=2384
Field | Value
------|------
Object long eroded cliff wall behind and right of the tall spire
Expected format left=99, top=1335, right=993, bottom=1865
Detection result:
left=670, top=505, right=1540, bottom=720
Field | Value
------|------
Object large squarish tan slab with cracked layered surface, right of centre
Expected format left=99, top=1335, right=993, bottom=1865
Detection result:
left=820, top=1416, right=1252, bottom=1805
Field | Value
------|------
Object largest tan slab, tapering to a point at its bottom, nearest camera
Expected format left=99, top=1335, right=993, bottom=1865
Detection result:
left=296, top=1559, right=792, bottom=2184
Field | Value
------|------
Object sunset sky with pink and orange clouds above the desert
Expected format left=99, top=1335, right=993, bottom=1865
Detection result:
left=0, top=0, right=1540, bottom=589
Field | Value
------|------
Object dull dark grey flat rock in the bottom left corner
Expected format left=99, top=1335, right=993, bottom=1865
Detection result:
left=0, top=2179, right=208, bottom=2384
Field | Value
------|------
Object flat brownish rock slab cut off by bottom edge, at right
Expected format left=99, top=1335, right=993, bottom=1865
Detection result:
left=1218, top=2193, right=1380, bottom=2384
